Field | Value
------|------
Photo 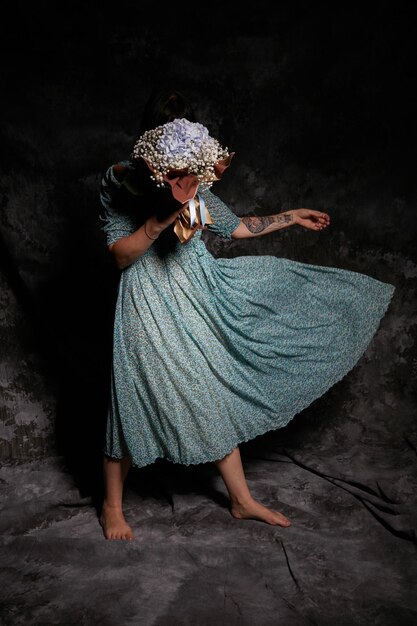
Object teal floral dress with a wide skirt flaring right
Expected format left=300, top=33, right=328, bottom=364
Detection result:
left=100, top=161, right=395, bottom=467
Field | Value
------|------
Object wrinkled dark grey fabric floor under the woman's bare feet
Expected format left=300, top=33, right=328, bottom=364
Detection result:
left=0, top=380, right=417, bottom=626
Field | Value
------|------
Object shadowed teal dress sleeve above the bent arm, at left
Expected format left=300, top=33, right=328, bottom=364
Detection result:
left=99, top=161, right=137, bottom=246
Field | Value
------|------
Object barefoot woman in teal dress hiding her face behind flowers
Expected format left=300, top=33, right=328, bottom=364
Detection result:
left=96, top=85, right=395, bottom=539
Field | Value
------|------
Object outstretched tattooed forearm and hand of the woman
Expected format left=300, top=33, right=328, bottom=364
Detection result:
left=230, top=209, right=330, bottom=239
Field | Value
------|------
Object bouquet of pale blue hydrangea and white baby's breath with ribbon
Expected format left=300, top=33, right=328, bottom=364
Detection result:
left=131, top=118, right=235, bottom=243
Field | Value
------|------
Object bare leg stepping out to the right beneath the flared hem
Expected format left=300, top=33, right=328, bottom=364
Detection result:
left=215, top=448, right=291, bottom=526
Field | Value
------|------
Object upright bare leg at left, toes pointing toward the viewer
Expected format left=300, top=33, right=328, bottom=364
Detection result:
left=100, top=455, right=134, bottom=539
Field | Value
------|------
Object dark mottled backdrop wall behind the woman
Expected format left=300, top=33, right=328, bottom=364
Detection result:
left=0, top=2, right=417, bottom=480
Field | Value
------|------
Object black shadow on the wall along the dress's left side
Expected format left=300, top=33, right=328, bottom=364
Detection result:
left=49, top=178, right=119, bottom=500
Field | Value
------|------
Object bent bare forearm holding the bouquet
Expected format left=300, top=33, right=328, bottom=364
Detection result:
left=108, top=205, right=184, bottom=269
